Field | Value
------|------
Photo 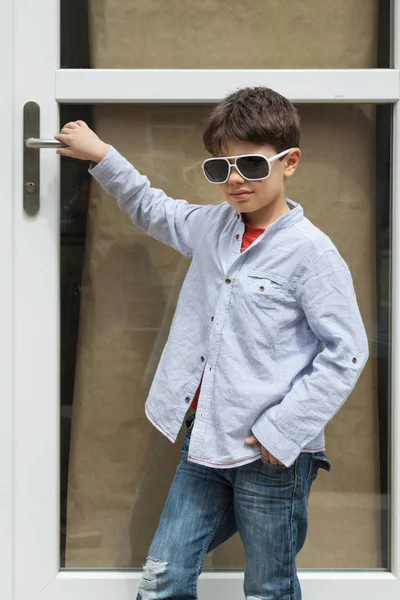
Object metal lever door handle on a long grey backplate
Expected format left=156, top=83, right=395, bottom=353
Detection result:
left=23, top=102, right=66, bottom=217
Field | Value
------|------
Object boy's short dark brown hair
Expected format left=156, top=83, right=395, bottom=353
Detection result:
left=203, top=87, right=300, bottom=156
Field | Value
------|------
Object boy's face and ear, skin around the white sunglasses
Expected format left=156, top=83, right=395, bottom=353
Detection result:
left=219, top=140, right=301, bottom=218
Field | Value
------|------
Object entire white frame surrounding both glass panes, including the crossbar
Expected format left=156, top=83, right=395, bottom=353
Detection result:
left=0, top=0, right=400, bottom=600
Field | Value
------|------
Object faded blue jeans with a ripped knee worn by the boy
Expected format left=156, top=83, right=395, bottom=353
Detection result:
left=137, top=418, right=331, bottom=600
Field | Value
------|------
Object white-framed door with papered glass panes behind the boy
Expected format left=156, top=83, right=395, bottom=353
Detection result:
left=0, top=0, right=400, bottom=600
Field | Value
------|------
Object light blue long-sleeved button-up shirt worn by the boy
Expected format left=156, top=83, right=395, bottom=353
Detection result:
left=90, top=148, right=368, bottom=468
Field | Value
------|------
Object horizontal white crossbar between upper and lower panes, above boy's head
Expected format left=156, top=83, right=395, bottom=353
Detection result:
left=56, top=69, right=399, bottom=104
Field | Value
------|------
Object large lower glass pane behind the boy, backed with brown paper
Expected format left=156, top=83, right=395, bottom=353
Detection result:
left=61, top=105, right=391, bottom=569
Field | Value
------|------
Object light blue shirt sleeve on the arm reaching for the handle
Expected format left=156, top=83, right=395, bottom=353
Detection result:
left=89, top=147, right=212, bottom=258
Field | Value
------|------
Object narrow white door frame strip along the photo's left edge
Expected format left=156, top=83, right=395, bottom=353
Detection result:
left=0, top=0, right=14, bottom=599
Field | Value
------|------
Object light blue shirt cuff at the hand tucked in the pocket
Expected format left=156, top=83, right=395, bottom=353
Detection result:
left=251, top=413, right=301, bottom=467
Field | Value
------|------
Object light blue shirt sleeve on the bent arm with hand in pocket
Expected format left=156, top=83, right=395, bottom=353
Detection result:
left=252, top=250, right=368, bottom=467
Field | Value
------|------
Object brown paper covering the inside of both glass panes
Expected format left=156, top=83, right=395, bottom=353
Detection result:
left=66, top=0, right=381, bottom=568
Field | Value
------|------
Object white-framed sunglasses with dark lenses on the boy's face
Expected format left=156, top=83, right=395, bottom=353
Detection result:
left=203, top=148, right=294, bottom=183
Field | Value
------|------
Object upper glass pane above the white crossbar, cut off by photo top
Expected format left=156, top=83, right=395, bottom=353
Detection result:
left=61, top=0, right=392, bottom=69
